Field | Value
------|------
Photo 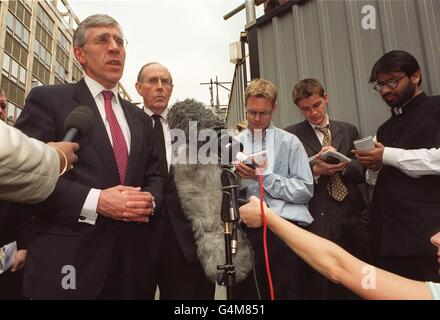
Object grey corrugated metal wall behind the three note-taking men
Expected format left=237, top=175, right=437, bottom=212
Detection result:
left=227, top=0, right=440, bottom=135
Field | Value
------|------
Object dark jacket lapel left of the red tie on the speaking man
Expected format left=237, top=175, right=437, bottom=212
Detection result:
left=73, top=79, right=119, bottom=184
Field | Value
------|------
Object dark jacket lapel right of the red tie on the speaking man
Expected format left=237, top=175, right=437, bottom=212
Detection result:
left=119, top=96, right=142, bottom=185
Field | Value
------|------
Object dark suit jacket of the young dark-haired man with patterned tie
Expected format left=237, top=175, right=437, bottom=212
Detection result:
left=285, top=120, right=365, bottom=247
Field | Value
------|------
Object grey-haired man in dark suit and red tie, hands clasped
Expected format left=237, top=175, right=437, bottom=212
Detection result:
left=16, top=15, right=163, bottom=299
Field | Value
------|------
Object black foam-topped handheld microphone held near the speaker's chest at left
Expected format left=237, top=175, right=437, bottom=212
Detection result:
left=63, top=106, right=93, bottom=142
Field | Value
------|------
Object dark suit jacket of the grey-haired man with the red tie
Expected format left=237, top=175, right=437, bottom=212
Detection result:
left=16, top=79, right=163, bottom=299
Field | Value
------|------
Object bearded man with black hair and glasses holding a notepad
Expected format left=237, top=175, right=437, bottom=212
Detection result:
left=354, top=50, right=440, bottom=282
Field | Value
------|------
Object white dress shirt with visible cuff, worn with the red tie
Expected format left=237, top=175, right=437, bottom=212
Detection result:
left=78, top=75, right=131, bottom=225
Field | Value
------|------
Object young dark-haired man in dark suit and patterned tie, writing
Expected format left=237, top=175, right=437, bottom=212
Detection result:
left=285, top=79, right=365, bottom=299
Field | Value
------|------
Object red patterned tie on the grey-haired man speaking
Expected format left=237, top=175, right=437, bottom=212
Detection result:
left=102, top=90, right=128, bottom=184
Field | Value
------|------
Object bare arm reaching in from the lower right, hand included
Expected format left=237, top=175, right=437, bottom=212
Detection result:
left=240, top=197, right=432, bottom=300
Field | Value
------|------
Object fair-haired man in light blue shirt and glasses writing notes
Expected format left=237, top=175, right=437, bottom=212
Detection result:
left=236, top=79, right=313, bottom=299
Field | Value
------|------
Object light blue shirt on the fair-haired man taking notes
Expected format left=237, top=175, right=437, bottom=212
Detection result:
left=235, top=123, right=313, bottom=225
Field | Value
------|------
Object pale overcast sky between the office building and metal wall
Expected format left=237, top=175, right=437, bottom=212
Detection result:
left=69, top=0, right=263, bottom=105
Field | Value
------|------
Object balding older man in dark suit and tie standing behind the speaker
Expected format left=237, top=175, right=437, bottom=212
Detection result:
left=136, top=62, right=215, bottom=300
